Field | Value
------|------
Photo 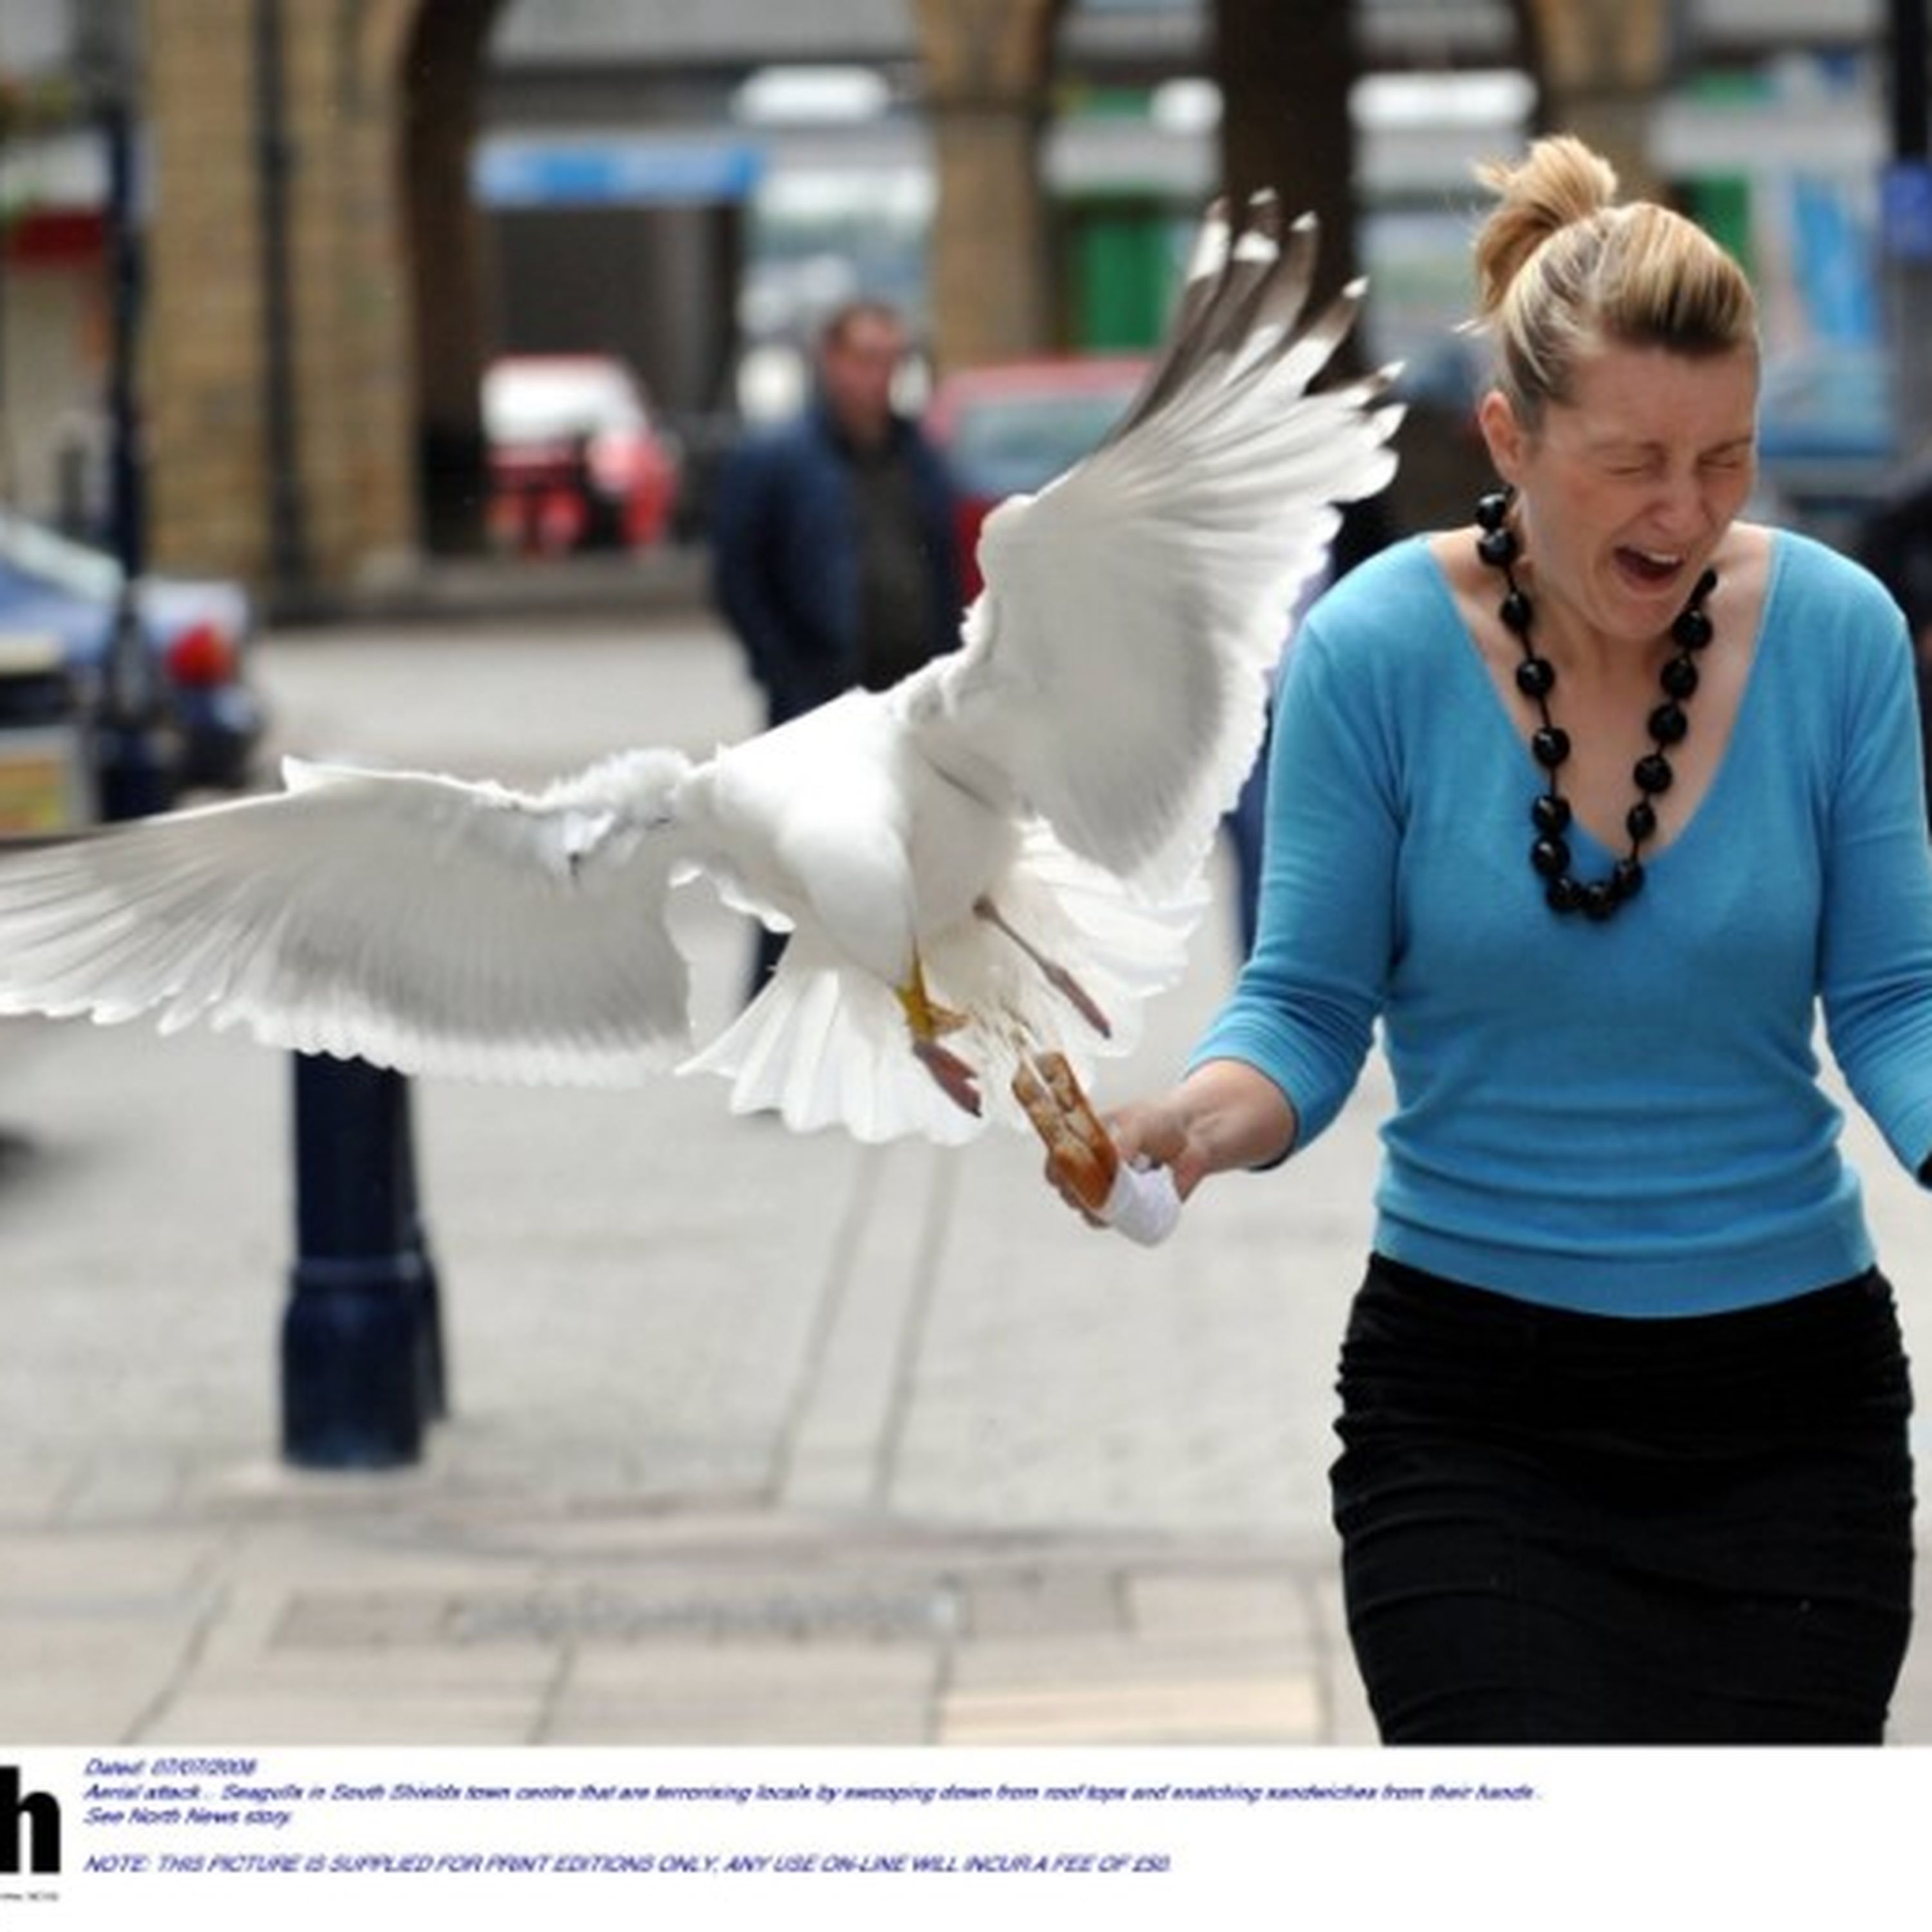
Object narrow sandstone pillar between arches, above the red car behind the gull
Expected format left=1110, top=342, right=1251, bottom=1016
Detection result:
left=914, top=0, right=1065, bottom=369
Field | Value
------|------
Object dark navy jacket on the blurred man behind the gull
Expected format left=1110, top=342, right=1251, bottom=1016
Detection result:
left=711, top=402, right=962, bottom=723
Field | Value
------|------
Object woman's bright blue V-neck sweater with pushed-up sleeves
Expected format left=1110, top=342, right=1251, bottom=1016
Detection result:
left=1194, top=535, right=1932, bottom=1316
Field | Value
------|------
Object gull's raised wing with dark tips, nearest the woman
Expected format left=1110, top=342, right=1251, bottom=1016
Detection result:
left=902, top=197, right=1401, bottom=895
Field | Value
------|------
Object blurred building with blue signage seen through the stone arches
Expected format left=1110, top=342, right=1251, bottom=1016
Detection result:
left=464, top=0, right=1897, bottom=545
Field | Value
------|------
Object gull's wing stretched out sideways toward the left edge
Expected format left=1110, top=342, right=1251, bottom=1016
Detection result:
left=0, top=752, right=703, bottom=1084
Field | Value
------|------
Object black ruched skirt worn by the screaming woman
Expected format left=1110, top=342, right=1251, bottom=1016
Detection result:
left=1331, top=1258, right=1913, bottom=1745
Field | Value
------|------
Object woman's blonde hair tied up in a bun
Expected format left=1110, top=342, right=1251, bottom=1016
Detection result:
left=1476, top=135, right=1758, bottom=427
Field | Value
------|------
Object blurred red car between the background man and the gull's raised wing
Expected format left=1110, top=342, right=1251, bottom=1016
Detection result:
left=925, top=355, right=1148, bottom=595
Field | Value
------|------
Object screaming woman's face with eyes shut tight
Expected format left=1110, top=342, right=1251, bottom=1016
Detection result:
left=1480, top=348, right=1758, bottom=638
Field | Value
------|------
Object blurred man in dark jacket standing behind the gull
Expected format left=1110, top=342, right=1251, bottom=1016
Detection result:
left=713, top=299, right=962, bottom=991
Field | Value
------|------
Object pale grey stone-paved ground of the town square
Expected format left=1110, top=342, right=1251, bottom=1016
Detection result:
left=0, top=553, right=1932, bottom=1748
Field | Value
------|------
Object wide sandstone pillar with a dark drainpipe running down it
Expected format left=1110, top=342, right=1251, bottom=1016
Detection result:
left=143, top=0, right=419, bottom=597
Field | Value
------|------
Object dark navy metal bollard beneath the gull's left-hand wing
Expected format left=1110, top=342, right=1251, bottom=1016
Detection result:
left=282, top=1055, right=448, bottom=1468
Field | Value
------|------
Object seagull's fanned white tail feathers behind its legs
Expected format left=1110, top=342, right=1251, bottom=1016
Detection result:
left=678, top=821, right=1208, bottom=1146
